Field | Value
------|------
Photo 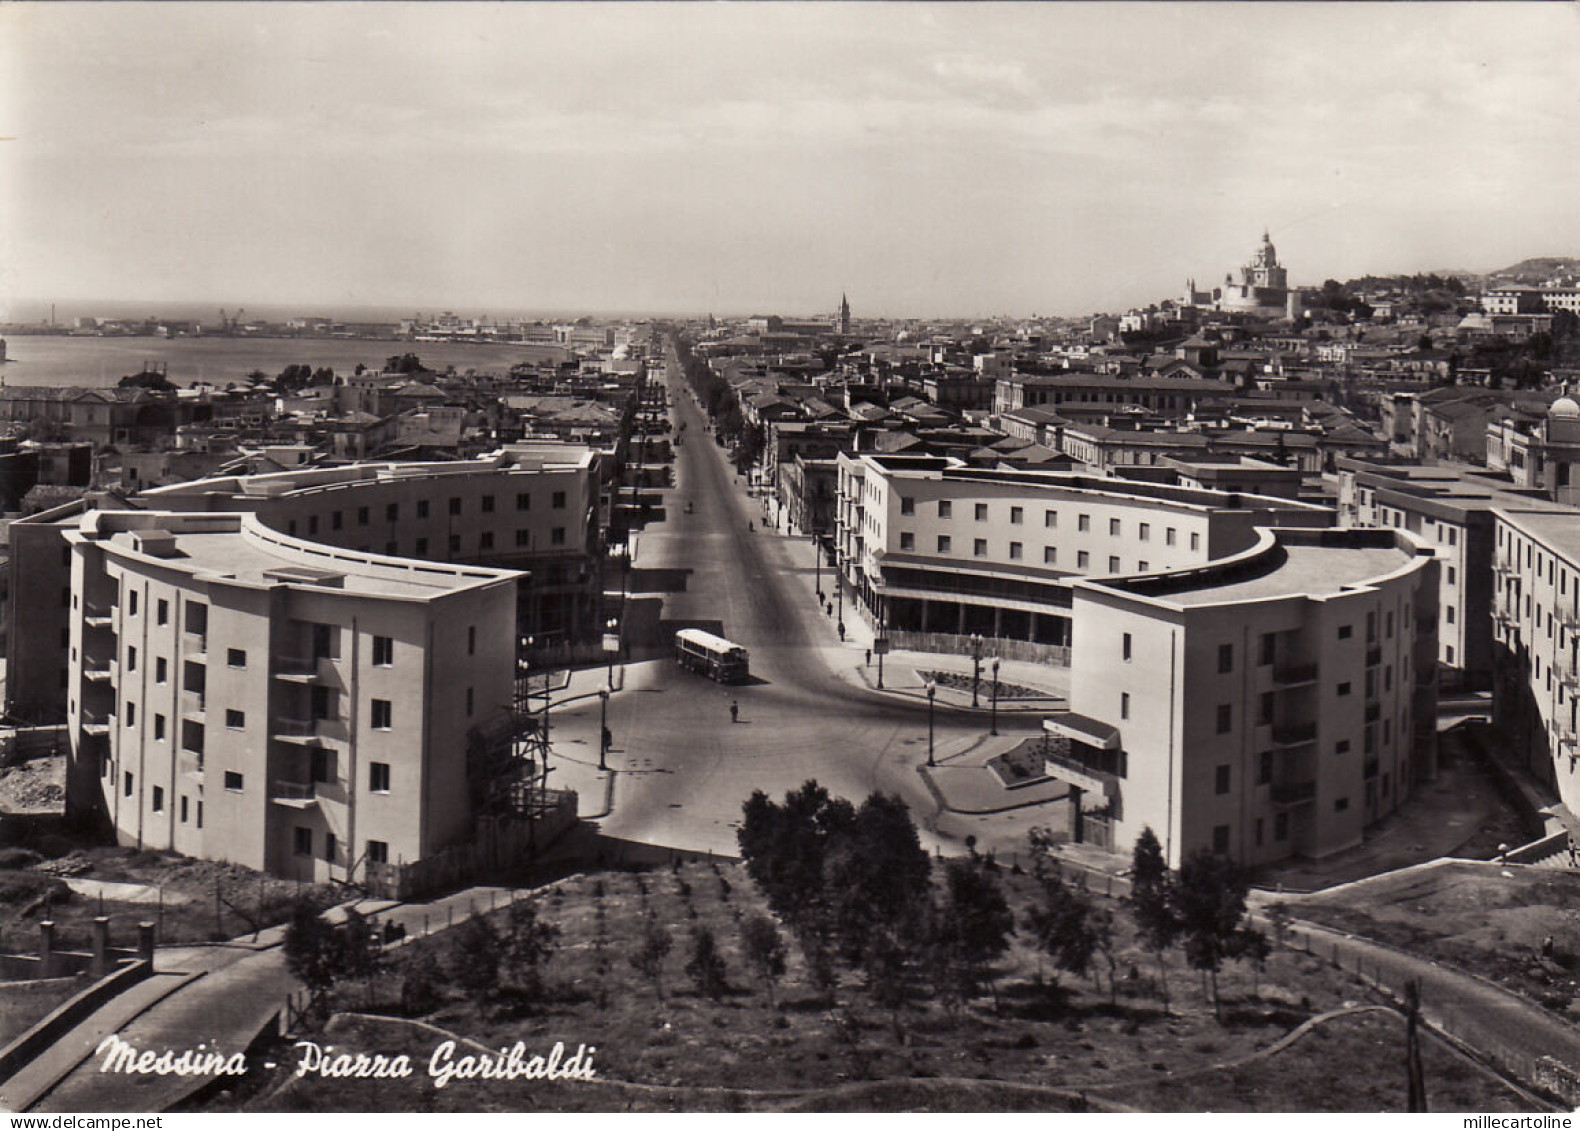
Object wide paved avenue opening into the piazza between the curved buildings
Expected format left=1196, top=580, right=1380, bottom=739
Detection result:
left=581, top=353, right=1051, bottom=855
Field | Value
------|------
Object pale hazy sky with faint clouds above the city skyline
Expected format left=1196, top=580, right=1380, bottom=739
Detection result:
left=0, top=3, right=1580, bottom=318
